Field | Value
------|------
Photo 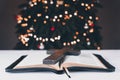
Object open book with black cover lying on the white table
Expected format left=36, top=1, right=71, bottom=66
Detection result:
left=6, top=53, right=115, bottom=74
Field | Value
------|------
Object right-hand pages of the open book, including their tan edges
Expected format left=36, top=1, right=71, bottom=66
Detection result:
left=62, top=53, right=106, bottom=68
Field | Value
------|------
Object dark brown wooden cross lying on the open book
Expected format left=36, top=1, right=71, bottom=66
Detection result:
left=43, top=48, right=80, bottom=64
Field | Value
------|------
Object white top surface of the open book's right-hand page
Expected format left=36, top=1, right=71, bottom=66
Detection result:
left=64, top=53, right=106, bottom=68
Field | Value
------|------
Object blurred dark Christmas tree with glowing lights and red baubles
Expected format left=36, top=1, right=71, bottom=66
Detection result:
left=15, top=0, right=101, bottom=50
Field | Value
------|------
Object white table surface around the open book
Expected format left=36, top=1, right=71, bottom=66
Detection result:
left=0, top=50, right=120, bottom=80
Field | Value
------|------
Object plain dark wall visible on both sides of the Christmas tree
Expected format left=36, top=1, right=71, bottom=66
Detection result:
left=0, top=0, right=120, bottom=50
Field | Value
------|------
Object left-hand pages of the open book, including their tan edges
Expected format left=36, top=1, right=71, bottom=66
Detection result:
left=14, top=51, right=59, bottom=70
